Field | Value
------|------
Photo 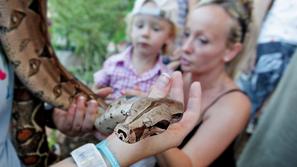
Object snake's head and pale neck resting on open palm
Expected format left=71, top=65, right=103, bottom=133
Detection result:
left=95, top=97, right=183, bottom=143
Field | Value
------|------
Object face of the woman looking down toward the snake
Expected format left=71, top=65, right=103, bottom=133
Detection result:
left=181, top=5, right=232, bottom=73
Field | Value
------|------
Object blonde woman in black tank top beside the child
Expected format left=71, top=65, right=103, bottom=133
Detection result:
left=158, top=0, right=251, bottom=167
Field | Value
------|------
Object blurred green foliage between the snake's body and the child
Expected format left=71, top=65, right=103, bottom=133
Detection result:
left=48, top=0, right=134, bottom=84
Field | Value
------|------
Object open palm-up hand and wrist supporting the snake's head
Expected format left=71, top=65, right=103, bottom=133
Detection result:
left=107, top=72, right=201, bottom=166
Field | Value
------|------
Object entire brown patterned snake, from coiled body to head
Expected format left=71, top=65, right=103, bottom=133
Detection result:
left=0, top=0, right=183, bottom=166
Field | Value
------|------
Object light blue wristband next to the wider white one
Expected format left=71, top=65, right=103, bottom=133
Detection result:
left=96, top=140, right=120, bottom=167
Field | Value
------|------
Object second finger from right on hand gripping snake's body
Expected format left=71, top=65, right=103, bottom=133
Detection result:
left=72, top=96, right=86, bottom=132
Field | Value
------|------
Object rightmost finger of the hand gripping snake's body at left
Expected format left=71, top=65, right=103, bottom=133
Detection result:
left=82, top=100, right=98, bottom=132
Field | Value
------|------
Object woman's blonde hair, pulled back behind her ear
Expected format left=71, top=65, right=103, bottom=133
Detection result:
left=196, top=0, right=252, bottom=77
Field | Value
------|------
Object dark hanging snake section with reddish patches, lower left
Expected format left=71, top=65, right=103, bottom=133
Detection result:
left=11, top=78, right=58, bottom=166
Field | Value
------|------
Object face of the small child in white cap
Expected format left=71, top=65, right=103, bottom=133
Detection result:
left=131, top=14, right=171, bottom=54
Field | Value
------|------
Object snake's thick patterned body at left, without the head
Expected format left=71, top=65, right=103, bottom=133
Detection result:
left=0, top=0, right=106, bottom=166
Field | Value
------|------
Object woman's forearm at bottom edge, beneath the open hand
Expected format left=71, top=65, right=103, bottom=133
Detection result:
left=157, top=148, right=193, bottom=167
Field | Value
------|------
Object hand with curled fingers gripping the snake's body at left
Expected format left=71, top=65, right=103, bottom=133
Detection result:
left=53, top=96, right=98, bottom=136
